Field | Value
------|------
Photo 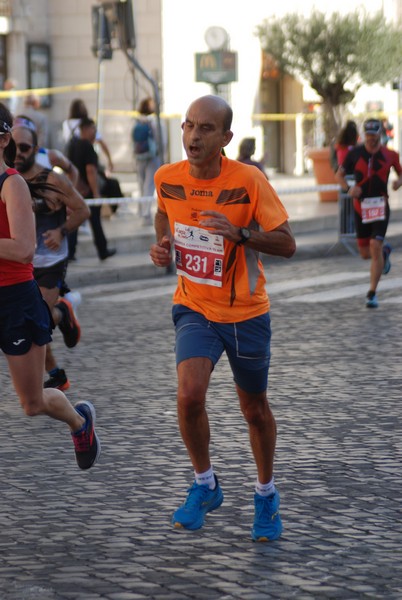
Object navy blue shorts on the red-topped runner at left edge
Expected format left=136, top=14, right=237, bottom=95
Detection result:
left=0, top=280, right=53, bottom=356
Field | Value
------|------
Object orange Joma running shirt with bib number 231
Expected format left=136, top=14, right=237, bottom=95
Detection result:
left=155, top=156, right=288, bottom=323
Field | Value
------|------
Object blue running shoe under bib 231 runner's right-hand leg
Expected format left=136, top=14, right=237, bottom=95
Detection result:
left=251, top=491, right=282, bottom=542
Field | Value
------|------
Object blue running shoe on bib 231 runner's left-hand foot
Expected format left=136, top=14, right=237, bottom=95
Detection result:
left=172, top=475, right=223, bottom=529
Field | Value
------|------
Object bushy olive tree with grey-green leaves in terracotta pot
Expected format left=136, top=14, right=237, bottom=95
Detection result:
left=256, top=11, right=402, bottom=143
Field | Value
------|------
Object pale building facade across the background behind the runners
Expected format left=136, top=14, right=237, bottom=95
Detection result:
left=0, top=0, right=402, bottom=173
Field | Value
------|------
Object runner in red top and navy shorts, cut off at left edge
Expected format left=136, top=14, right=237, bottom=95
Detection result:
left=0, top=104, right=100, bottom=469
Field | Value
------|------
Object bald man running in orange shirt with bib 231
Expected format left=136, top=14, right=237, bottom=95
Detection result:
left=150, top=95, right=295, bottom=541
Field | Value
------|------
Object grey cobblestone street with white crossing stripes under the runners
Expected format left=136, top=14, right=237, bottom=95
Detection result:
left=0, top=251, right=402, bottom=600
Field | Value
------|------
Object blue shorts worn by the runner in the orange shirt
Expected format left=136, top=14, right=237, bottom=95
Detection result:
left=172, top=304, right=271, bottom=394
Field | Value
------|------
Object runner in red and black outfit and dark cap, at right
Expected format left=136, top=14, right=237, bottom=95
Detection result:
left=336, top=119, right=402, bottom=308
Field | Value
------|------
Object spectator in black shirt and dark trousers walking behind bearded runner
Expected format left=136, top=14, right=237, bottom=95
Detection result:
left=67, top=117, right=116, bottom=260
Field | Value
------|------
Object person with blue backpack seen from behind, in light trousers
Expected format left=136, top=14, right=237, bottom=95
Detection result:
left=131, top=97, right=162, bottom=225
